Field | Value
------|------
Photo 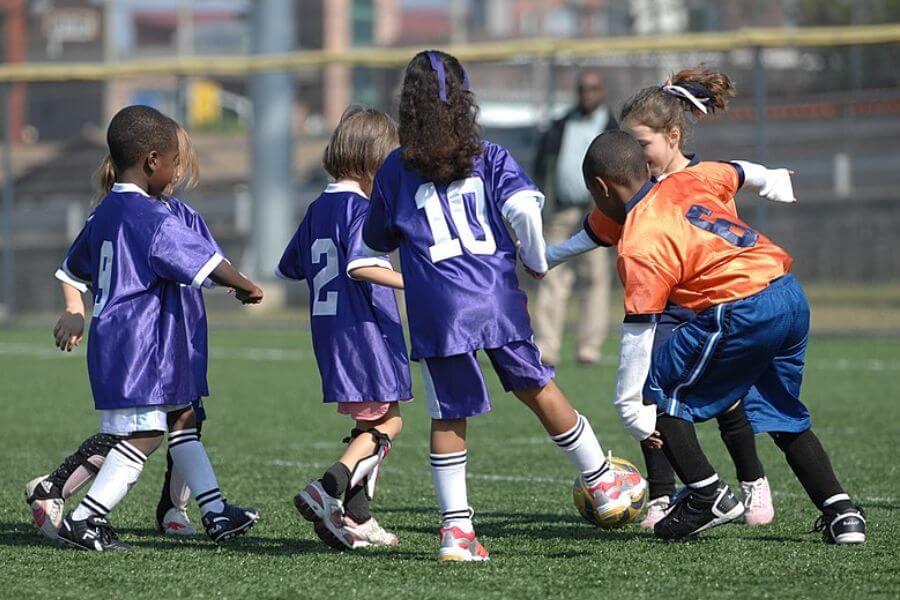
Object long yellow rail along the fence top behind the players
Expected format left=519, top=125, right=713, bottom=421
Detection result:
left=0, top=23, right=900, bottom=83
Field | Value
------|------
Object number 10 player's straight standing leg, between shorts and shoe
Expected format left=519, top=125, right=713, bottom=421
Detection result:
left=430, top=418, right=473, bottom=533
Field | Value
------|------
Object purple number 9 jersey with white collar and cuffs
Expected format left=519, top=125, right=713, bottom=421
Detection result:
left=62, top=184, right=222, bottom=410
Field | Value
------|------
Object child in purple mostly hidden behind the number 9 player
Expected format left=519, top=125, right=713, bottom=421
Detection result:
left=25, top=126, right=222, bottom=540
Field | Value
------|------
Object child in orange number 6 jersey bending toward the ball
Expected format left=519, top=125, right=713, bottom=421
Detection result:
left=583, top=132, right=866, bottom=544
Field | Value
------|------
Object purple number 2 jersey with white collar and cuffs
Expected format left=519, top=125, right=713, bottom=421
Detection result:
left=276, top=183, right=412, bottom=402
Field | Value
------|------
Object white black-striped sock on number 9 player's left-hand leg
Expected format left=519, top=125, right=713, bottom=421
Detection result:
left=72, top=440, right=147, bottom=521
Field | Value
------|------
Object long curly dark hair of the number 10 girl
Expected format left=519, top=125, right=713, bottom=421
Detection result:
left=398, top=50, right=483, bottom=183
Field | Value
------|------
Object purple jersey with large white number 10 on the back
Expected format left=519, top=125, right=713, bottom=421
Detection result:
left=363, top=142, right=543, bottom=360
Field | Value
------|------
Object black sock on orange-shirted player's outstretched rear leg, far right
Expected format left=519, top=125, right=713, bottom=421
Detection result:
left=770, top=429, right=853, bottom=511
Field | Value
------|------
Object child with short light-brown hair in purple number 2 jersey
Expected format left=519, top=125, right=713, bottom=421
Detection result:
left=276, top=106, right=412, bottom=549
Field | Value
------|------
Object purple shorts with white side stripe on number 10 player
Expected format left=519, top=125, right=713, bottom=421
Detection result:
left=419, top=340, right=554, bottom=419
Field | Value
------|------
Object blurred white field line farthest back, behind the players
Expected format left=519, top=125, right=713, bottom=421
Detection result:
left=0, top=342, right=900, bottom=371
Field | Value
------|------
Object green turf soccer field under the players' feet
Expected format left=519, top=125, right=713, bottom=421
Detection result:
left=0, top=329, right=900, bottom=599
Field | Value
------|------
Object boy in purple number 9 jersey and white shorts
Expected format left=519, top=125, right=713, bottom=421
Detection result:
left=49, top=106, right=262, bottom=551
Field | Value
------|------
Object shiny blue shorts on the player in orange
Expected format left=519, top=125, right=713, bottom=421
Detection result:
left=644, top=275, right=811, bottom=433
